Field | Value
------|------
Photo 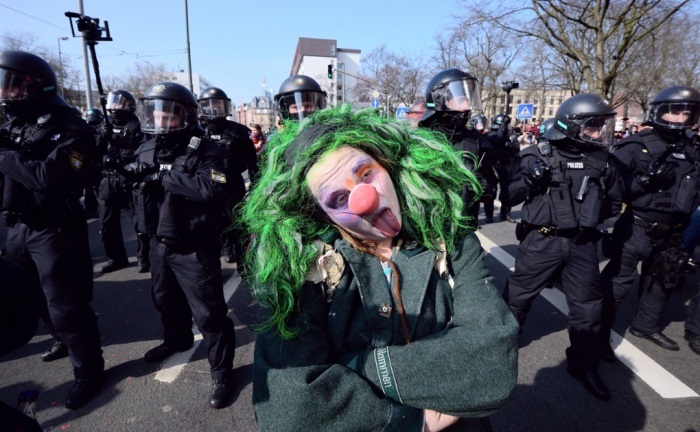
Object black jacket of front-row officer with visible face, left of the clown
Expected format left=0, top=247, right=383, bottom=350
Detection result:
left=135, top=131, right=227, bottom=244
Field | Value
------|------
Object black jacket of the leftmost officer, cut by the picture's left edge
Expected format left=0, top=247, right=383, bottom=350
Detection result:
left=0, top=107, right=95, bottom=229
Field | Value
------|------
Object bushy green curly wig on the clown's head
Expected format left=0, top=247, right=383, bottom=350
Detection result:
left=240, top=105, right=481, bottom=339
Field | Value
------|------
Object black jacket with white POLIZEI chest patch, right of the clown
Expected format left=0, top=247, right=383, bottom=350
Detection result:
left=507, top=139, right=623, bottom=230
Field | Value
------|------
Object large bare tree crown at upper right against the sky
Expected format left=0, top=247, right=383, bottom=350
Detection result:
left=474, top=0, right=691, bottom=98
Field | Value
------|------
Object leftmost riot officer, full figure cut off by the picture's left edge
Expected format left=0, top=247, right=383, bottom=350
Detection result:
left=0, top=51, right=104, bottom=409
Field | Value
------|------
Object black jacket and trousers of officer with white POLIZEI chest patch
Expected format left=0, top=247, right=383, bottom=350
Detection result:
left=504, top=138, right=622, bottom=372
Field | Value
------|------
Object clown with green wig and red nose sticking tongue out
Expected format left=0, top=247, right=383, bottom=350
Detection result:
left=242, top=106, right=518, bottom=431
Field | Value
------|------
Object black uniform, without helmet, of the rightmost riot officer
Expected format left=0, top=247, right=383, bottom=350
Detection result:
left=602, top=128, right=700, bottom=338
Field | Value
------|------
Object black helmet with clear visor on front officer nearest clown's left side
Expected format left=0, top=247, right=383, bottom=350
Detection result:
left=139, top=82, right=199, bottom=134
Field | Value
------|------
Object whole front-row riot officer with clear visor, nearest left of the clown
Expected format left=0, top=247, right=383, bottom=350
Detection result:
left=124, top=82, right=235, bottom=408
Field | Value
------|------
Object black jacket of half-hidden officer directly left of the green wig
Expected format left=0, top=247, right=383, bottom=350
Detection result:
left=205, top=119, right=258, bottom=202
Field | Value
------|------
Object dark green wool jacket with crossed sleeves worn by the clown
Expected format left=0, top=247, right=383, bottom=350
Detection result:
left=253, top=234, right=518, bottom=432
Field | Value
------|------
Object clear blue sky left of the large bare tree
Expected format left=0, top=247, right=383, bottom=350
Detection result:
left=0, top=0, right=465, bottom=104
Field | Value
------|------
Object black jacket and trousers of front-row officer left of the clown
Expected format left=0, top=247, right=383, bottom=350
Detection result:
left=136, top=132, right=235, bottom=381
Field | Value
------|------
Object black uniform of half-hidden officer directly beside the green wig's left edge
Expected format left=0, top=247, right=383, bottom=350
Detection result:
left=205, top=119, right=258, bottom=264
